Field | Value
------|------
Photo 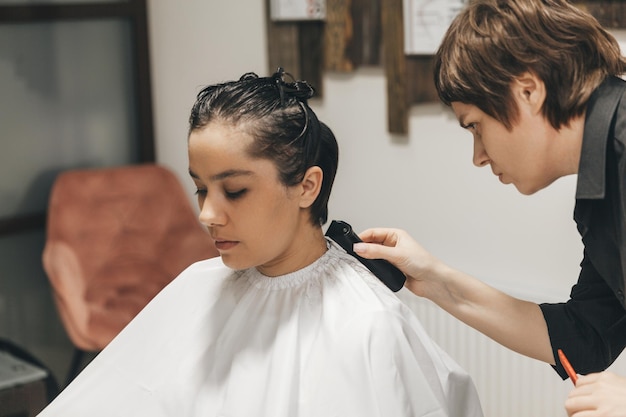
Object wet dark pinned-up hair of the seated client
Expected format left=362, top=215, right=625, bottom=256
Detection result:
left=189, top=68, right=339, bottom=225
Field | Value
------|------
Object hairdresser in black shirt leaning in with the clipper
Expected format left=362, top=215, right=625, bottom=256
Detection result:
left=354, top=0, right=626, bottom=417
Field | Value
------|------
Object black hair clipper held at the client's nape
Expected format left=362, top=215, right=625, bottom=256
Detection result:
left=326, top=220, right=406, bottom=292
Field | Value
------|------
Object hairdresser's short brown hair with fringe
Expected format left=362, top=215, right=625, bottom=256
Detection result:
left=434, top=0, right=626, bottom=129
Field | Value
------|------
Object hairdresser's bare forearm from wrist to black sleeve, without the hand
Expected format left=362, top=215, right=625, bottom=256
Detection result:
left=407, top=264, right=554, bottom=364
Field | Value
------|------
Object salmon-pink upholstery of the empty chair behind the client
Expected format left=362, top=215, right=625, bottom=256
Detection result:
left=43, top=164, right=218, bottom=351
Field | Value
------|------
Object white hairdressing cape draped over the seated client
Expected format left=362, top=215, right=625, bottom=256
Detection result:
left=40, top=242, right=482, bottom=417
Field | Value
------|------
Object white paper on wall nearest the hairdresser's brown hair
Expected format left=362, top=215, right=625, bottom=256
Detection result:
left=402, top=0, right=467, bottom=55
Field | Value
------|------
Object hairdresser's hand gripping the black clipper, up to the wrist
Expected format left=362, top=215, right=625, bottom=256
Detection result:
left=354, top=228, right=443, bottom=297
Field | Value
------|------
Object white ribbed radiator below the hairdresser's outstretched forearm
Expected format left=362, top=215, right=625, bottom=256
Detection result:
left=400, top=289, right=576, bottom=417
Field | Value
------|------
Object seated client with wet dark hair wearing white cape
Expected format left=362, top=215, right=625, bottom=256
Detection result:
left=36, top=70, right=482, bottom=417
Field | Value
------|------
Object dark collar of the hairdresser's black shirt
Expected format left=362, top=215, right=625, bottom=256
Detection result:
left=576, top=77, right=624, bottom=199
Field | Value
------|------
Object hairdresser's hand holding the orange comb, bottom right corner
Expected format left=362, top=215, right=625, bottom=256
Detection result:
left=565, top=371, right=626, bottom=417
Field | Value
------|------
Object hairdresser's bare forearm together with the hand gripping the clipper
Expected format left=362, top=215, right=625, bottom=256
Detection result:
left=354, top=229, right=554, bottom=364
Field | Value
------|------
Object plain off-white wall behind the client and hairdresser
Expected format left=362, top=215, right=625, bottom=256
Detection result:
left=149, top=0, right=626, bottom=415
